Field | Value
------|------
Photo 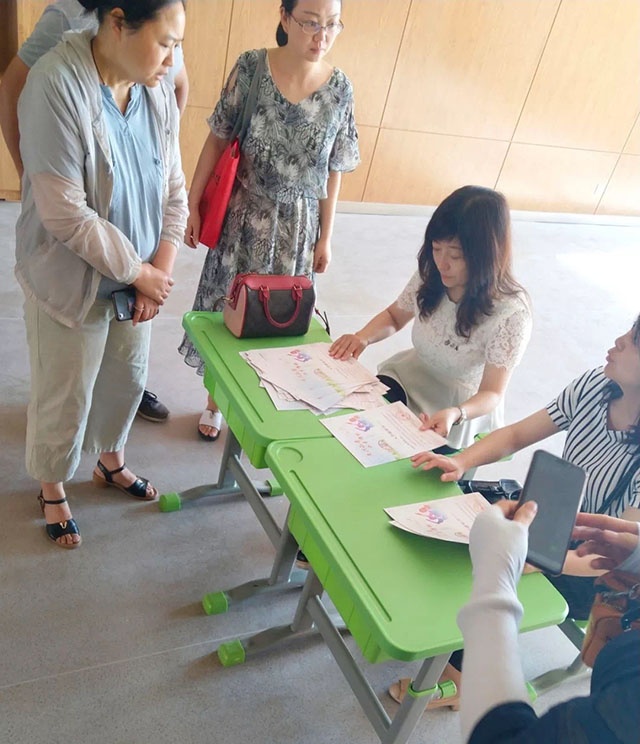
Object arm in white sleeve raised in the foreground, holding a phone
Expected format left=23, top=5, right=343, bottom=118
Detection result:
left=458, top=508, right=528, bottom=742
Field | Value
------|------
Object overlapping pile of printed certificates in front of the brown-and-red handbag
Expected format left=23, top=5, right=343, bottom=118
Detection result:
left=240, top=343, right=388, bottom=413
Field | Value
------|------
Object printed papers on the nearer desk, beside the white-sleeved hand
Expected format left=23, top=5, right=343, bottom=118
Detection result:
left=385, top=493, right=491, bottom=544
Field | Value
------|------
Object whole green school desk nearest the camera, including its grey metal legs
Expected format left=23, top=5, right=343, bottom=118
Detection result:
left=212, top=438, right=567, bottom=744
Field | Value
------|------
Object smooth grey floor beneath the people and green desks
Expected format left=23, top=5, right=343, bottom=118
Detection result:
left=0, top=203, right=640, bottom=744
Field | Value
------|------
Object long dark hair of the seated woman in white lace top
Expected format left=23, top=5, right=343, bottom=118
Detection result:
left=417, top=186, right=524, bottom=338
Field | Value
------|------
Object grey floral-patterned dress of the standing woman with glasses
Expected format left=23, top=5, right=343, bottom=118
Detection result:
left=179, top=49, right=360, bottom=374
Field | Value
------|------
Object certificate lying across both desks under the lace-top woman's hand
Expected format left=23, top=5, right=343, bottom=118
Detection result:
left=321, top=403, right=447, bottom=468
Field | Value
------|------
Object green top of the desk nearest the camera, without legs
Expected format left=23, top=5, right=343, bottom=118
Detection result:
left=266, top=438, right=567, bottom=661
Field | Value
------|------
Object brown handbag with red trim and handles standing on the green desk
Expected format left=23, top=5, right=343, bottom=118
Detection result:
left=222, top=274, right=316, bottom=338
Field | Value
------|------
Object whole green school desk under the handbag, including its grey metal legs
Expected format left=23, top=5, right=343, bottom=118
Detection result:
left=165, top=312, right=338, bottom=614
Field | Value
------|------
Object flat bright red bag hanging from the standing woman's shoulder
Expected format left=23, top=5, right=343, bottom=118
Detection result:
left=200, top=137, right=240, bottom=248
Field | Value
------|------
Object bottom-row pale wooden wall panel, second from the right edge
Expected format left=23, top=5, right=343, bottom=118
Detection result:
left=496, top=144, right=617, bottom=213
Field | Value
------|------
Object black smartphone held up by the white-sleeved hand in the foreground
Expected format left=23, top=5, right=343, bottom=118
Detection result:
left=518, top=450, right=586, bottom=576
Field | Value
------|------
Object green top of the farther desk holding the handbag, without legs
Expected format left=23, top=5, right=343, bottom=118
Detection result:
left=182, top=312, right=331, bottom=468
